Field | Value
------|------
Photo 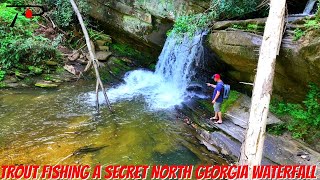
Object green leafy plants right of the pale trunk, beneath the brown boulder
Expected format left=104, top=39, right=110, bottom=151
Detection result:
left=270, top=84, right=320, bottom=138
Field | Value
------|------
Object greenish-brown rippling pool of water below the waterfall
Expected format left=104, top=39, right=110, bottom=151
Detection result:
left=0, top=83, right=225, bottom=165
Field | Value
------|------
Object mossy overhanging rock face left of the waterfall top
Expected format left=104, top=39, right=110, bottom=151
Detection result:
left=88, top=0, right=210, bottom=55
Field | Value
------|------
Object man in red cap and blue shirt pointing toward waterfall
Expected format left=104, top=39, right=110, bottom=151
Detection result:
left=207, top=74, right=224, bottom=124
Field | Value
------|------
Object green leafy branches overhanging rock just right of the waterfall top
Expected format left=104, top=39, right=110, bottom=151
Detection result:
left=211, top=0, right=260, bottom=19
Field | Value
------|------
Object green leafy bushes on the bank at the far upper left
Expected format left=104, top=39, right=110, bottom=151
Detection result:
left=0, top=3, right=59, bottom=69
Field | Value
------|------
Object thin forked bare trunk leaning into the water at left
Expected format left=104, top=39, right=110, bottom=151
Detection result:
left=70, top=0, right=112, bottom=111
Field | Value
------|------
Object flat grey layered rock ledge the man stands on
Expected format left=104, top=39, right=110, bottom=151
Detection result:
left=182, top=94, right=320, bottom=169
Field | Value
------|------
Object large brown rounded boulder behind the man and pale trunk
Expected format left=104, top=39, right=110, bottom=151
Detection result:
left=209, top=27, right=320, bottom=101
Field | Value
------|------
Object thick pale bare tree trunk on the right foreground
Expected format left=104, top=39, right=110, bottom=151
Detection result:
left=239, top=0, right=286, bottom=179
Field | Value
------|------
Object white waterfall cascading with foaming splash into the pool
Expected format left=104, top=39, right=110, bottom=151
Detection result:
left=91, top=31, right=206, bottom=110
